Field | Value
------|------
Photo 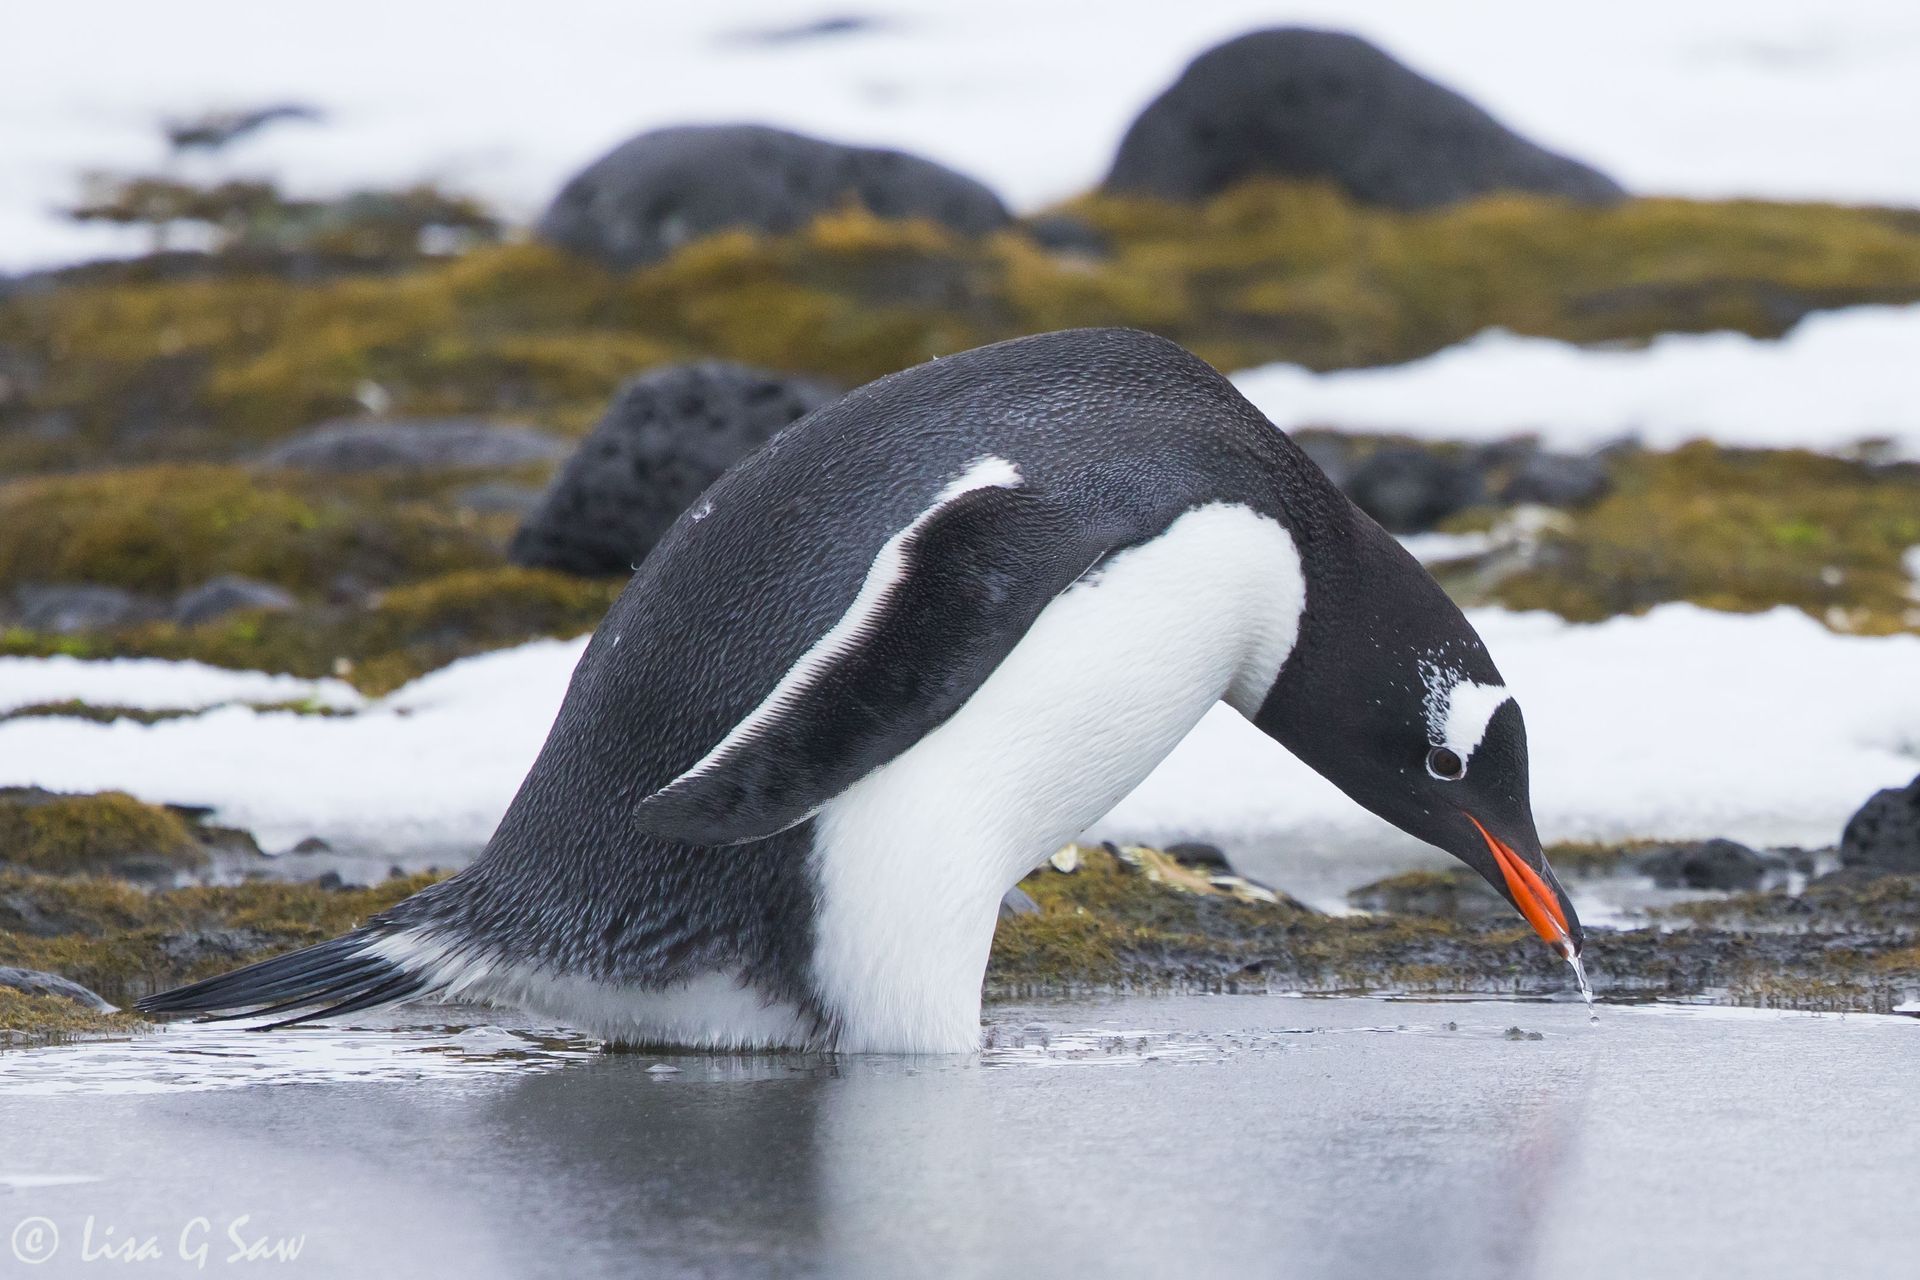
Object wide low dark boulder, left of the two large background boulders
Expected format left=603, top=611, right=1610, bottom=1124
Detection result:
left=536, top=125, right=1010, bottom=267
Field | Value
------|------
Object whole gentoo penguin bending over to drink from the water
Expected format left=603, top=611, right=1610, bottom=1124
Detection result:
left=140, top=330, right=1580, bottom=1052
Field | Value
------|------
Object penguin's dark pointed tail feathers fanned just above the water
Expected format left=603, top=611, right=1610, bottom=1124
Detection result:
left=136, top=929, right=434, bottom=1031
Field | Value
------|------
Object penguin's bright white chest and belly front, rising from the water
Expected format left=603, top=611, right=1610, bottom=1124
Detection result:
left=812, top=505, right=1306, bottom=1052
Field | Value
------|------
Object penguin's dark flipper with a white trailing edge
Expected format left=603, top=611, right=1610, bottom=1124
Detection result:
left=637, top=475, right=1117, bottom=844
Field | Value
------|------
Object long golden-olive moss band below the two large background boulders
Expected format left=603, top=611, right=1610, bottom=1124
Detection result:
left=15, top=182, right=1920, bottom=466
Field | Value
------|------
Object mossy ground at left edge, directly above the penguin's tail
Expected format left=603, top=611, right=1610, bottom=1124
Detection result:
left=0, top=871, right=438, bottom=1006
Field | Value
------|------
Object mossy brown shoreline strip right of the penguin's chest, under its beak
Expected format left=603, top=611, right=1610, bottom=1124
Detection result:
left=987, top=852, right=1920, bottom=1011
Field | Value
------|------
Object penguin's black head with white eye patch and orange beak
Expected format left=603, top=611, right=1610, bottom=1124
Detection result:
left=1254, top=518, right=1582, bottom=956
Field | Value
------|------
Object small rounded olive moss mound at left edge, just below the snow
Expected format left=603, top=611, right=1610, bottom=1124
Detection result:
left=0, top=791, right=205, bottom=875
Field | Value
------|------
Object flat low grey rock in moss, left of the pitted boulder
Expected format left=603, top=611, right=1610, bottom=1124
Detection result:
left=259, top=418, right=568, bottom=472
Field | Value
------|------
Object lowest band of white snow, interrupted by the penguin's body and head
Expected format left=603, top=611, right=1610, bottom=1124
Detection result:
left=0, top=604, right=1920, bottom=883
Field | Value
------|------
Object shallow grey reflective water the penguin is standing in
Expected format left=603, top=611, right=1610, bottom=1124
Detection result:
left=0, top=996, right=1920, bottom=1280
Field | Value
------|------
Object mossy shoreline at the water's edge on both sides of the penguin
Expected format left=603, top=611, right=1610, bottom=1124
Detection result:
left=0, top=850, right=1920, bottom=1038
